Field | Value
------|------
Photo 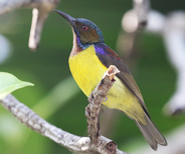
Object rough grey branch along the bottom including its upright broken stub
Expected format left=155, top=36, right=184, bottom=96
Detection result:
left=0, top=66, right=126, bottom=154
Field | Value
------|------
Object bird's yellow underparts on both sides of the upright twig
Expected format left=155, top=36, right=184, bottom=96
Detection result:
left=69, top=45, right=144, bottom=122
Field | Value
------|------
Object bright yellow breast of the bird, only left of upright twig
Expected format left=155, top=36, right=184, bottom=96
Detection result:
left=69, top=45, right=107, bottom=97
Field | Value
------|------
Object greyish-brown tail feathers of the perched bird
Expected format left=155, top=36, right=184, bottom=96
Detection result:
left=136, top=114, right=167, bottom=151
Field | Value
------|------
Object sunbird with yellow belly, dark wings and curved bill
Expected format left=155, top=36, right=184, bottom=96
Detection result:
left=54, top=10, right=167, bottom=151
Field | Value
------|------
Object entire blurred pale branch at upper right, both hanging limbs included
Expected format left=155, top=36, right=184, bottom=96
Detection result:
left=117, top=0, right=185, bottom=115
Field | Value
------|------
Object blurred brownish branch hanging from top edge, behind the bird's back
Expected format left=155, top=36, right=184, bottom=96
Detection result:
left=117, top=0, right=150, bottom=62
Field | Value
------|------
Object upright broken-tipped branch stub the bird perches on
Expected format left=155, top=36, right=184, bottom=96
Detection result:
left=85, top=65, right=119, bottom=145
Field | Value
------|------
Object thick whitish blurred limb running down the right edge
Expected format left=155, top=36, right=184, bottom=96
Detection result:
left=163, top=11, right=185, bottom=115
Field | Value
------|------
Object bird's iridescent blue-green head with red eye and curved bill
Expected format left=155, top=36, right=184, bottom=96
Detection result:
left=54, top=10, right=104, bottom=48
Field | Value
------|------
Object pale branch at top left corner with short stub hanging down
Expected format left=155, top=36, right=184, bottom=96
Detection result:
left=0, top=0, right=59, bottom=50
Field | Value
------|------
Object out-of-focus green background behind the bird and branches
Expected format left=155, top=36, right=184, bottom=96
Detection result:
left=0, top=0, right=185, bottom=154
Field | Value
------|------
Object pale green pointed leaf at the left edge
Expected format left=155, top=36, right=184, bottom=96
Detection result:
left=0, top=72, right=33, bottom=99
